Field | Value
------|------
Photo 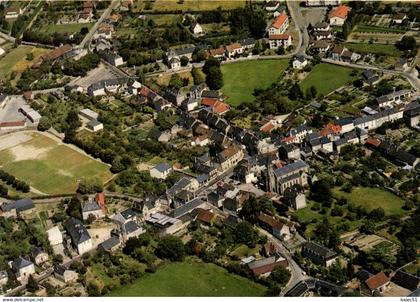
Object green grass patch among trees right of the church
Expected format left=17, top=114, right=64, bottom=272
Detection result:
left=333, top=187, right=404, bottom=215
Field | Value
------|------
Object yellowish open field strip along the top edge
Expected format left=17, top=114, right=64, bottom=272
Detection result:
left=148, top=0, right=245, bottom=11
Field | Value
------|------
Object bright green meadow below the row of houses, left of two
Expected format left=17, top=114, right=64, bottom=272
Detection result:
left=222, top=60, right=289, bottom=106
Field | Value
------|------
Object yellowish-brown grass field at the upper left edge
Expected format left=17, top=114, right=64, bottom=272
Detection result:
left=0, top=45, right=49, bottom=77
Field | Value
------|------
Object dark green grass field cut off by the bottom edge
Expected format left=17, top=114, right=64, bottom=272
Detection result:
left=108, top=261, right=265, bottom=297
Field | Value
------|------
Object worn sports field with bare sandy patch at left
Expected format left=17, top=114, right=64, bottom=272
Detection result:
left=0, top=132, right=112, bottom=194
